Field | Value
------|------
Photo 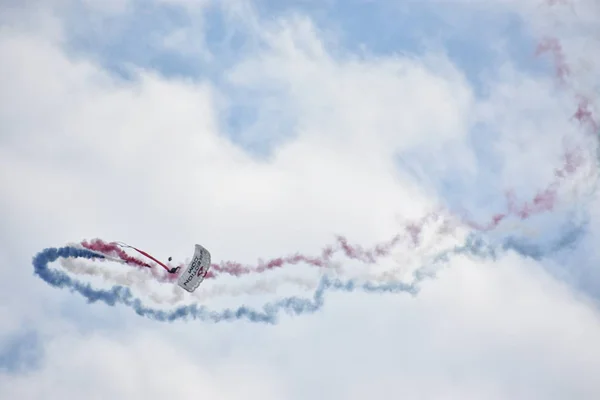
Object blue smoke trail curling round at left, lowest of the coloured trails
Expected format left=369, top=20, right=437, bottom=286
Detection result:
left=33, top=222, right=584, bottom=324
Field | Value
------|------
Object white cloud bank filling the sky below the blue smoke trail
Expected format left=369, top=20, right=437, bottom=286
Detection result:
left=0, top=256, right=600, bottom=399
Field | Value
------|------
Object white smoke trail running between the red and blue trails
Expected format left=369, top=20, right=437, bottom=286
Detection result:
left=60, top=211, right=468, bottom=305
